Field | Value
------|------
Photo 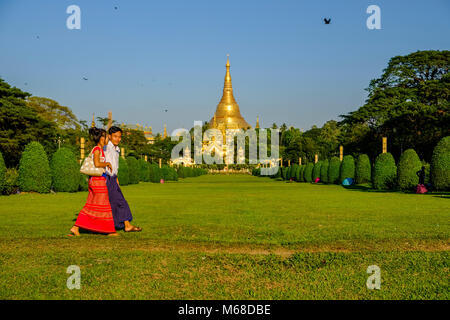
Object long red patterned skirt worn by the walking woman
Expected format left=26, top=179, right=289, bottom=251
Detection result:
left=75, top=177, right=116, bottom=233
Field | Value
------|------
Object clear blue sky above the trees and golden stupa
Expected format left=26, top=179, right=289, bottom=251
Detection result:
left=0, top=0, right=450, bottom=132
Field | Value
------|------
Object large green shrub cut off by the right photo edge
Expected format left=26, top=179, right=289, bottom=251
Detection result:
left=430, top=136, right=450, bottom=190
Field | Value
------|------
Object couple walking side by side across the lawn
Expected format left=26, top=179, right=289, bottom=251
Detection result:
left=70, top=126, right=142, bottom=236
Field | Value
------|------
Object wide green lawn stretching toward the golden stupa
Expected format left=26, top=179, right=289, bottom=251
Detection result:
left=0, top=175, right=450, bottom=299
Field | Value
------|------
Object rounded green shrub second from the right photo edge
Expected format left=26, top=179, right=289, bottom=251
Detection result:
left=397, top=149, right=422, bottom=190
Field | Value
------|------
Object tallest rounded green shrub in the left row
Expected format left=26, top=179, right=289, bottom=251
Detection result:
left=19, top=141, right=52, bottom=193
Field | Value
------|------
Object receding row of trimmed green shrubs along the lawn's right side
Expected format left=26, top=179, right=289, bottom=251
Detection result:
left=252, top=136, right=450, bottom=191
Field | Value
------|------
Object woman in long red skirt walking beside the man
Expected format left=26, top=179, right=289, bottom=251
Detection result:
left=70, top=127, right=118, bottom=236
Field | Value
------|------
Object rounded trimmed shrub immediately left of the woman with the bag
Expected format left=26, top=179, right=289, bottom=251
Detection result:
left=50, top=148, right=80, bottom=192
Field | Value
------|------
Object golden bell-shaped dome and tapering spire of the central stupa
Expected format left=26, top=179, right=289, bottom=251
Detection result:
left=208, top=55, right=251, bottom=132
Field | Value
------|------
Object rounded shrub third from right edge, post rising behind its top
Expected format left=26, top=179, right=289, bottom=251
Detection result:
left=372, top=152, right=397, bottom=190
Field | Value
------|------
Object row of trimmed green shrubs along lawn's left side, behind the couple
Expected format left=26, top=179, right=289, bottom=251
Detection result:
left=0, top=142, right=207, bottom=194
